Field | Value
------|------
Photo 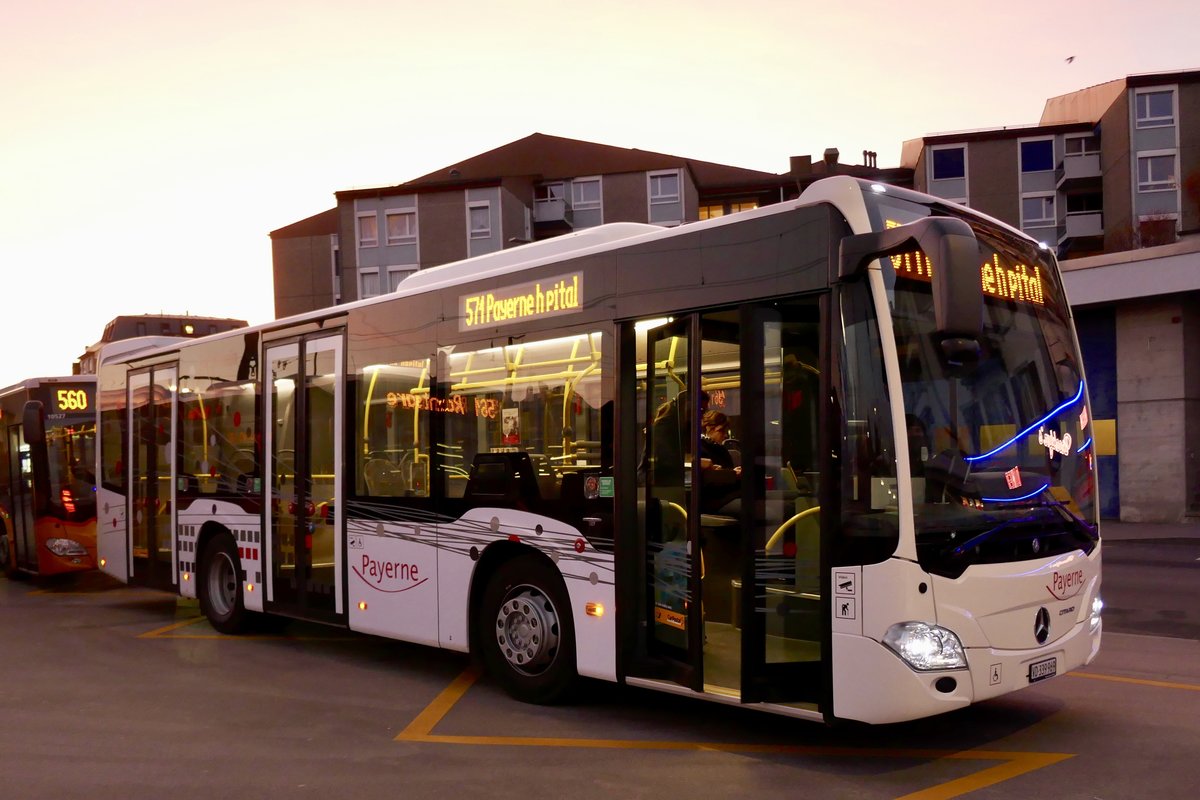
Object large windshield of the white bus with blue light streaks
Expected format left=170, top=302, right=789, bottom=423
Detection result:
left=864, top=198, right=1097, bottom=577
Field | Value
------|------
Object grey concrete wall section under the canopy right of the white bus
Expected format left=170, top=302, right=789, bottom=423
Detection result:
left=1116, top=295, right=1198, bottom=522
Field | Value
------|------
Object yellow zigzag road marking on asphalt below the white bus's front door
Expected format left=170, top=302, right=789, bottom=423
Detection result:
left=395, top=668, right=1074, bottom=800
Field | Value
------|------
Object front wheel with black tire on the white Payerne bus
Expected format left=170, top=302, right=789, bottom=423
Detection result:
left=479, top=555, right=578, bottom=705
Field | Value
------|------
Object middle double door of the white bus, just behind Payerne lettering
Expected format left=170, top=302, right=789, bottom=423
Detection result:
left=264, top=333, right=346, bottom=622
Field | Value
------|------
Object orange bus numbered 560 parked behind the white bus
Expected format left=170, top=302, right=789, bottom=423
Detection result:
left=0, top=375, right=96, bottom=577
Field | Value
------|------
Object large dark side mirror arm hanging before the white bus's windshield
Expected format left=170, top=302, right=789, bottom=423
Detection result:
left=839, top=217, right=983, bottom=363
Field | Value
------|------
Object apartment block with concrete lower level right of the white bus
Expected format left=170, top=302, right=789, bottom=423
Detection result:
left=901, top=71, right=1200, bottom=522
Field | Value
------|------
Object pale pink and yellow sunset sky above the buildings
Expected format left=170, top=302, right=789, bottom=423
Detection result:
left=0, top=0, right=1200, bottom=386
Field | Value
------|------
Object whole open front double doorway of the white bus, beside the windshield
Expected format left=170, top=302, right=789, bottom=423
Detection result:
left=618, top=297, right=829, bottom=706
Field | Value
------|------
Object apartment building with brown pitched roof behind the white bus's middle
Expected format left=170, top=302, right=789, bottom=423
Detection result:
left=271, top=133, right=912, bottom=317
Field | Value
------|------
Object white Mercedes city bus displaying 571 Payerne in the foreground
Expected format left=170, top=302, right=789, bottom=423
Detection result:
left=97, top=178, right=1100, bottom=722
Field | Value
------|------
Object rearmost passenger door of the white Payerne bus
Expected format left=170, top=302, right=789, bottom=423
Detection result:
left=126, top=366, right=179, bottom=590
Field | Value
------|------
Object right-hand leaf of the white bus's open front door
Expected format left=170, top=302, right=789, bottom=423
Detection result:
left=737, top=302, right=833, bottom=706
